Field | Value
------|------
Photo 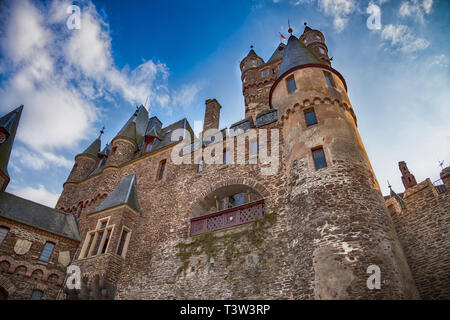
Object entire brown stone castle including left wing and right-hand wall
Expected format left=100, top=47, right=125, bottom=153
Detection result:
left=0, top=26, right=450, bottom=299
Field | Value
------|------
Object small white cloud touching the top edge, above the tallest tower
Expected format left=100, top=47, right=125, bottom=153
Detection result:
left=319, top=0, right=357, bottom=32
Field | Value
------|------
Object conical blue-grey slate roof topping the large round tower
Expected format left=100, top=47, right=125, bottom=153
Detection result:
left=277, top=36, right=326, bottom=78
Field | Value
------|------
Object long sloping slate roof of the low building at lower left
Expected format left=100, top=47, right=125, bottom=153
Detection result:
left=0, top=192, right=81, bottom=241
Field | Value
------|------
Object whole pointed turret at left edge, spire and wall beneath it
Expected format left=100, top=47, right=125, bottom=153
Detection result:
left=0, top=105, right=23, bottom=190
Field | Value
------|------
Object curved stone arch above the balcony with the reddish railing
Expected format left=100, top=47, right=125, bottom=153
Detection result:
left=191, top=178, right=269, bottom=217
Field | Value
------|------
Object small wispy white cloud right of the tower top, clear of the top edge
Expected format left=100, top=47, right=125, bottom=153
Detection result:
left=381, top=24, right=430, bottom=53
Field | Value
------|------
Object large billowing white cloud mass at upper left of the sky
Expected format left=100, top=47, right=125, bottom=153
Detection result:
left=0, top=0, right=198, bottom=168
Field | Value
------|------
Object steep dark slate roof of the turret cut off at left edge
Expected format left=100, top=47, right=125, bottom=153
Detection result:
left=0, top=106, right=23, bottom=176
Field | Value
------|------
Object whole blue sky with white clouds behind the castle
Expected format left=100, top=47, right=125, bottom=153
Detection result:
left=0, top=0, right=450, bottom=206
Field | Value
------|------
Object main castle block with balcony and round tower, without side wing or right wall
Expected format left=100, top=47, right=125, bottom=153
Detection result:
left=52, top=26, right=418, bottom=299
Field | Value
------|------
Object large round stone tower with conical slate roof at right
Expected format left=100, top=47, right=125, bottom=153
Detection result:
left=269, top=27, right=418, bottom=299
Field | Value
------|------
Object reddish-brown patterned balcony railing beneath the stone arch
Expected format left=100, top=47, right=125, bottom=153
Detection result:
left=191, top=199, right=264, bottom=236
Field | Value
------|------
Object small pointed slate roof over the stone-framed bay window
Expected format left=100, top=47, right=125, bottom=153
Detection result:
left=94, top=173, right=140, bottom=212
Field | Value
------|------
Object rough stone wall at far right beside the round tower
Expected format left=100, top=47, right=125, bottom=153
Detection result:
left=386, top=179, right=450, bottom=299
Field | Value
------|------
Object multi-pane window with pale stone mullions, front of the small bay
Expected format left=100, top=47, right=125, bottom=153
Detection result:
left=80, top=217, right=114, bottom=259
